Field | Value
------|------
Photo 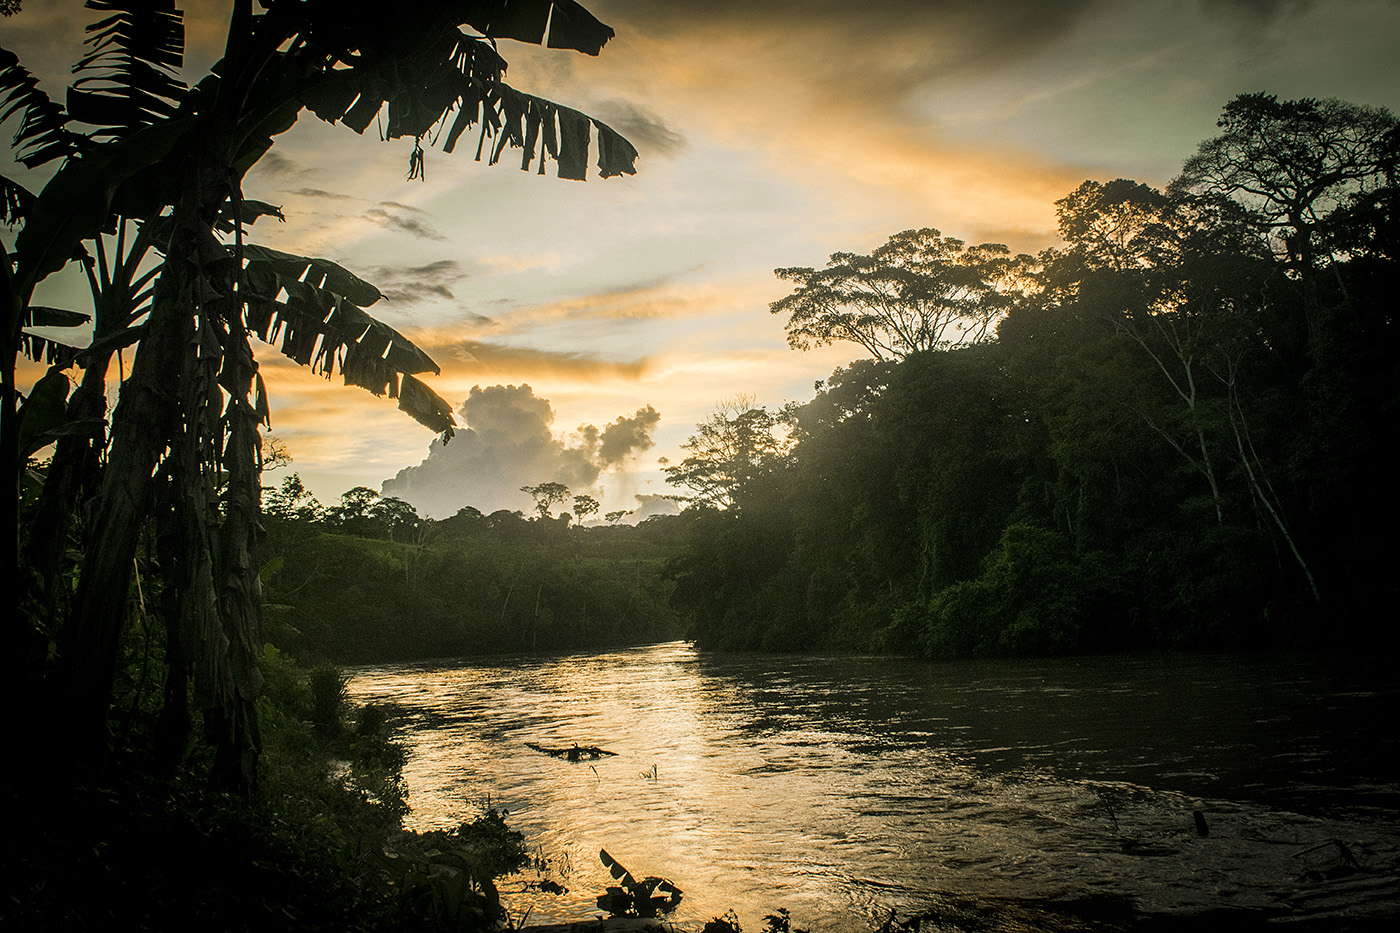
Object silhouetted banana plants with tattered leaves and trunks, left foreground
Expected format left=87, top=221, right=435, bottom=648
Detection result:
left=0, top=0, right=636, bottom=786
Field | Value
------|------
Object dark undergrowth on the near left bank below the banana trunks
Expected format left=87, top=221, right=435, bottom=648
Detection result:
left=0, top=647, right=529, bottom=933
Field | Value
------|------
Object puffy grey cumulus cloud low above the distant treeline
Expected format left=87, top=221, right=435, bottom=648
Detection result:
left=384, top=385, right=659, bottom=518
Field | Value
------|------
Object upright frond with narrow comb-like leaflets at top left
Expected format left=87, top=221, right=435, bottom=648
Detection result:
left=69, top=0, right=186, bottom=136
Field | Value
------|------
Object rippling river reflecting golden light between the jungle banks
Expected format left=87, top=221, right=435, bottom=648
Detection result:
left=350, top=643, right=1400, bottom=932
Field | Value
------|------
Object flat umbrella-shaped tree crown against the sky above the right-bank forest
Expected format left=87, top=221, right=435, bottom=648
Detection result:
left=769, top=227, right=1032, bottom=360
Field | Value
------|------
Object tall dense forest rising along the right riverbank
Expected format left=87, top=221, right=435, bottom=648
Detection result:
left=668, top=95, right=1400, bottom=657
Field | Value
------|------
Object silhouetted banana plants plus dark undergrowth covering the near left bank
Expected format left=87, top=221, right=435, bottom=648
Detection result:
left=0, top=0, right=637, bottom=930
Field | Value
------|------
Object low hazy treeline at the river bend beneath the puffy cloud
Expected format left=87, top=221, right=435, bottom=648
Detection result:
left=263, top=487, right=679, bottom=663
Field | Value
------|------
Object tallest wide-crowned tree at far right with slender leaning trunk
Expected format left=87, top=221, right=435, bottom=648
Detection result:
left=1172, top=94, right=1400, bottom=598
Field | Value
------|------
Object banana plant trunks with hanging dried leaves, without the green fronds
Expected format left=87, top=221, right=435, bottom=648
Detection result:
left=62, top=185, right=262, bottom=793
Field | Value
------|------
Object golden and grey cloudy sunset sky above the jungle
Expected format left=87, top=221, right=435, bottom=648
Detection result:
left=8, top=0, right=1400, bottom=517
